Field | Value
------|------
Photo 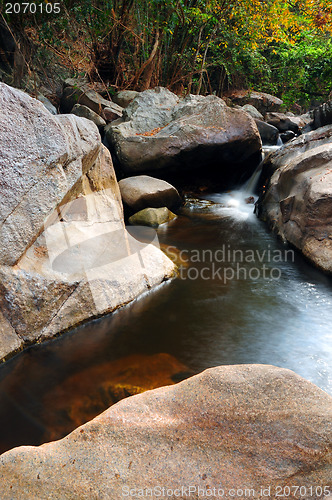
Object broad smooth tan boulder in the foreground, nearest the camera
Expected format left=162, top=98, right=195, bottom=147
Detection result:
left=0, top=365, right=332, bottom=500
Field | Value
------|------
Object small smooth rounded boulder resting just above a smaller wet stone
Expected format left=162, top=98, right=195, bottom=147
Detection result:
left=119, top=175, right=181, bottom=211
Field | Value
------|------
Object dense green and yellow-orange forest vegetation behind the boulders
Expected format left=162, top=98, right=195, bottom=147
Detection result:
left=0, top=0, right=332, bottom=105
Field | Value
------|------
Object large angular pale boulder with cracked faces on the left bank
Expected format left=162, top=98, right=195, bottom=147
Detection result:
left=0, top=84, right=174, bottom=358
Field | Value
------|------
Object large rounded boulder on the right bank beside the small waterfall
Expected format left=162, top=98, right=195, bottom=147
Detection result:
left=258, top=126, right=332, bottom=273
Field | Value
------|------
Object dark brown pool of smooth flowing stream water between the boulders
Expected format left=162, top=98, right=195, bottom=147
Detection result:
left=0, top=167, right=332, bottom=451
